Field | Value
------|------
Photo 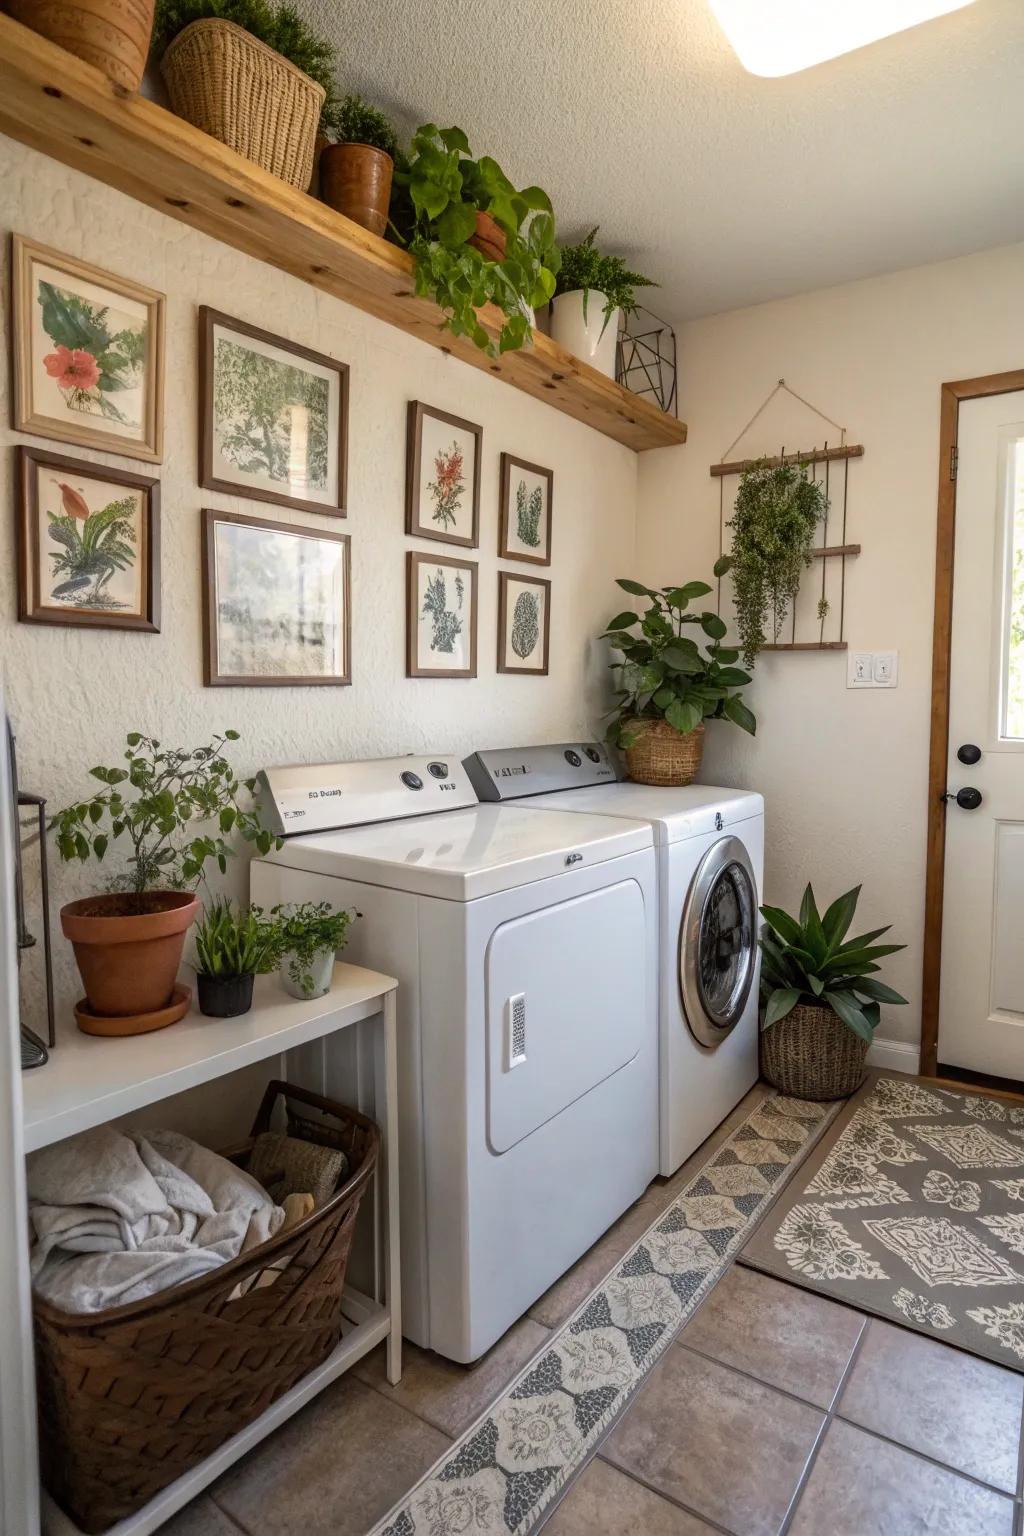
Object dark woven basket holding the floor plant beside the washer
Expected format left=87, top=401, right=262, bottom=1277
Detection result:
left=761, top=1003, right=867, bottom=1100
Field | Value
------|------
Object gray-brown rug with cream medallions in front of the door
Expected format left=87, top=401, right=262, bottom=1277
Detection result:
left=740, top=1075, right=1024, bottom=1370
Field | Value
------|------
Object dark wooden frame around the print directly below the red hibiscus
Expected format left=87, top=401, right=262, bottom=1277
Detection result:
left=17, top=445, right=160, bottom=634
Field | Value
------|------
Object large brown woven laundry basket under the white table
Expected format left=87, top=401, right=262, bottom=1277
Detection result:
left=34, top=1083, right=381, bottom=1533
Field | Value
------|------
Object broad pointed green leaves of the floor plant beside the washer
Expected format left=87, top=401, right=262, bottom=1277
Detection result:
left=760, top=886, right=906, bottom=1041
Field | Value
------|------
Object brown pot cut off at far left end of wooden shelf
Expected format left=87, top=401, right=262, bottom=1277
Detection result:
left=0, top=0, right=155, bottom=91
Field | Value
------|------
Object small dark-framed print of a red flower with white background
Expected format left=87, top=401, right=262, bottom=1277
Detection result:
left=405, top=399, right=484, bottom=550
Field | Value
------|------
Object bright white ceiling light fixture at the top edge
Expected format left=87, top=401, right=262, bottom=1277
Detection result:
left=711, top=0, right=973, bottom=77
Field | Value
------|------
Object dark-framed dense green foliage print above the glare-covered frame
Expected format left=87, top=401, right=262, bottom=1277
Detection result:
left=200, top=304, right=348, bottom=518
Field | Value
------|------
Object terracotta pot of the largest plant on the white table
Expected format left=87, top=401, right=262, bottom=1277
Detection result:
left=60, top=891, right=200, bottom=1015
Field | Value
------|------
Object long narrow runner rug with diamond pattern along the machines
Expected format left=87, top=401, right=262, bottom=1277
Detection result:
left=372, top=1095, right=835, bottom=1536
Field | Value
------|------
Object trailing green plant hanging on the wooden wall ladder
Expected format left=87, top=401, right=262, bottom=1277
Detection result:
left=728, top=459, right=829, bottom=667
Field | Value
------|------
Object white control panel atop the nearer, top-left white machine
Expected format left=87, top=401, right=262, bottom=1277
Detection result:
left=259, top=753, right=476, bottom=837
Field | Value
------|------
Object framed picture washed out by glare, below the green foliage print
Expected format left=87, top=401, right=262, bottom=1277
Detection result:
left=203, top=510, right=352, bottom=688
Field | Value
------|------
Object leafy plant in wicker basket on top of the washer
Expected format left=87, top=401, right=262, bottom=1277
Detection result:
left=602, top=561, right=757, bottom=783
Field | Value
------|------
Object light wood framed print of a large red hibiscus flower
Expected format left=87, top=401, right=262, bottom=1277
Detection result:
left=11, top=235, right=164, bottom=462
